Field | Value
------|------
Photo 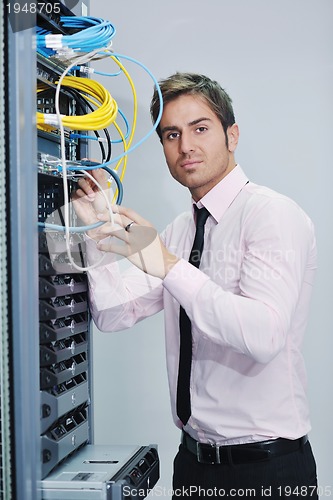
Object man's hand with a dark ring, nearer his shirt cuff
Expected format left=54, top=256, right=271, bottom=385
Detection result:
left=98, top=205, right=179, bottom=279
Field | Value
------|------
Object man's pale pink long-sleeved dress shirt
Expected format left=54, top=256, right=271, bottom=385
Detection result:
left=87, top=165, right=316, bottom=445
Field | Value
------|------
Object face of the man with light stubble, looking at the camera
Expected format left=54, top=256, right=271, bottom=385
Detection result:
left=160, top=95, right=238, bottom=201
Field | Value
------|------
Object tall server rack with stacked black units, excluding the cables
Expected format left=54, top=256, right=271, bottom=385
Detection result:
left=0, top=1, right=159, bottom=500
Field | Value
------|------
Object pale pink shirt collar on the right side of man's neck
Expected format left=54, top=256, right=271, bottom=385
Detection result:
left=193, top=164, right=248, bottom=222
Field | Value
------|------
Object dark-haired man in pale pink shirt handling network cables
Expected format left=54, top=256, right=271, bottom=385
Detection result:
left=74, top=73, right=317, bottom=498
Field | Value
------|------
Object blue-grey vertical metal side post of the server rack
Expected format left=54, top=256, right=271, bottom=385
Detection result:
left=5, top=3, right=40, bottom=500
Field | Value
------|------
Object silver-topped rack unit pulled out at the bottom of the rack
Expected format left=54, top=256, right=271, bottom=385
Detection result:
left=43, top=444, right=159, bottom=500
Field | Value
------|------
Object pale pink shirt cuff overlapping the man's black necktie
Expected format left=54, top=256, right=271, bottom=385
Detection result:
left=163, top=259, right=210, bottom=311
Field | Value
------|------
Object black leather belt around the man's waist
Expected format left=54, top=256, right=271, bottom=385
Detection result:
left=182, top=431, right=308, bottom=465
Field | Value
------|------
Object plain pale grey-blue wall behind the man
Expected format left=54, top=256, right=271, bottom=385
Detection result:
left=91, top=0, right=333, bottom=496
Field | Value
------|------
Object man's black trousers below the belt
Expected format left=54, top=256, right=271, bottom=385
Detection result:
left=173, top=442, right=318, bottom=500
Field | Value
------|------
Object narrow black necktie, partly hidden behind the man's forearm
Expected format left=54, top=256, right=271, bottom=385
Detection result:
left=177, top=206, right=209, bottom=425
